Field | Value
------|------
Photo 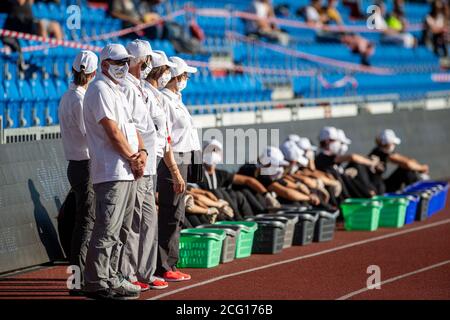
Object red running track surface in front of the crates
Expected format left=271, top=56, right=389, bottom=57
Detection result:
left=0, top=201, right=450, bottom=300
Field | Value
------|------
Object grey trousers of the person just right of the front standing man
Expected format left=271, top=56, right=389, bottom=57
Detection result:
left=120, top=176, right=158, bottom=283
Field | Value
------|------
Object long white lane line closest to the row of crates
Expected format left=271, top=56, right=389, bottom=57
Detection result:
left=147, top=219, right=450, bottom=300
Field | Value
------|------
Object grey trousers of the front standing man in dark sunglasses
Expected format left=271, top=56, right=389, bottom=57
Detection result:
left=84, top=181, right=136, bottom=291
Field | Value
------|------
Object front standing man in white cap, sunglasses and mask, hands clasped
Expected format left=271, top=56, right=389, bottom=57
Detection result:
left=83, top=44, right=147, bottom=299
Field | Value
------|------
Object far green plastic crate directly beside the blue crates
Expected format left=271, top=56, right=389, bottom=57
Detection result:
left=373, top=196, right=409, bottom=228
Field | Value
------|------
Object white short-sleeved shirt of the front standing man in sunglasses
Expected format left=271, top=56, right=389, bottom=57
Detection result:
left=83, top=74, right=139, bottom=184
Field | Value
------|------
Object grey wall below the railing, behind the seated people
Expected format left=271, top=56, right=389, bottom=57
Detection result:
left=0, top=110, right=450, bottom=273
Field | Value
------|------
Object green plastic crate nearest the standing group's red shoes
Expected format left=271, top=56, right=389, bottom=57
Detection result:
left=177, top=229, right=226, bottom=268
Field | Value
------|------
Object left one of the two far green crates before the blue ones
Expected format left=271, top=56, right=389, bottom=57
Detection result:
left=341, top=198, right=382, bottom=231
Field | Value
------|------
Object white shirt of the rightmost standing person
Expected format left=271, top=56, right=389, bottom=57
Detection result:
left=162, top=89, right=201, bottom=152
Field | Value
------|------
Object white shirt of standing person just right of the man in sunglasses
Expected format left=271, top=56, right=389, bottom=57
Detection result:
left=121, top=73, right=158, bottom=175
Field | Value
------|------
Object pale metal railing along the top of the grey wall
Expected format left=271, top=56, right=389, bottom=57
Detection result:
left=0, top=91, right=450, bottom=144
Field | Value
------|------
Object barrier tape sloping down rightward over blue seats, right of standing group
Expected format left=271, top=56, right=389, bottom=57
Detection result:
left=227, top=32, right=393, bottom=75
